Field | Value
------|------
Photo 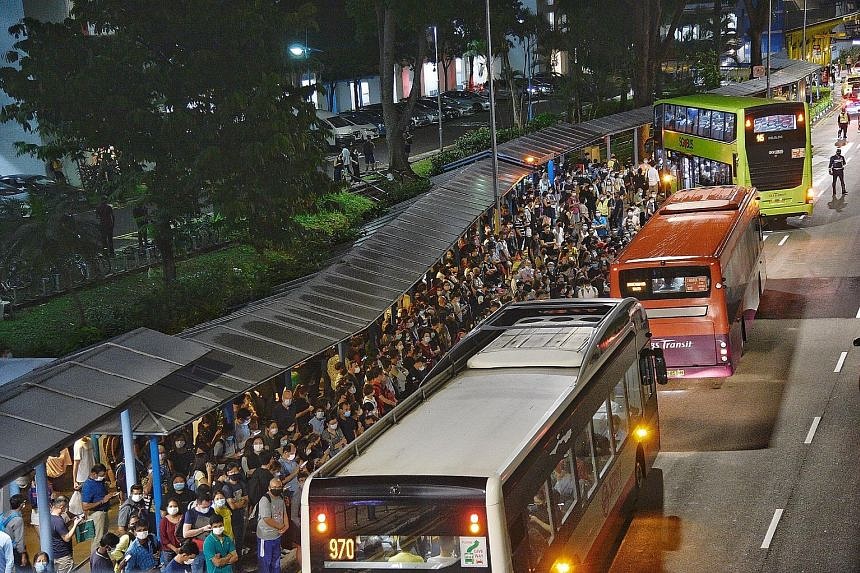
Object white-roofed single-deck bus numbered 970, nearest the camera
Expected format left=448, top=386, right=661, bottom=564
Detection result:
left=301, top=298, right=666, bottom=573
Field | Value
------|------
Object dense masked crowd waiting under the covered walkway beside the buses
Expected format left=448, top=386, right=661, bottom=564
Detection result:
left=0, top=156, right=663, bottom=573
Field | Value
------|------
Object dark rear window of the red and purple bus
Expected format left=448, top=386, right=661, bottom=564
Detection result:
left=619, top=267, right=711, bottom=300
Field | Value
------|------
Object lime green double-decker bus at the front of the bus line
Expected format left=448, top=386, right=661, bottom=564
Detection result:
left=654, top=94, right=815, bottom=218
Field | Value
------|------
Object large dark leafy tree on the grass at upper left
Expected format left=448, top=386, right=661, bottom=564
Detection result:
left=0, top=0, right=327, bottom=284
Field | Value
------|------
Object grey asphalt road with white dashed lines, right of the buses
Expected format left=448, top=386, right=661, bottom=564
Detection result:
left=610, top=106, right=860, bottom=573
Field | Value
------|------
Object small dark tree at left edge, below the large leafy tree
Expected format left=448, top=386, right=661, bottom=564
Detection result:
left=0, top=194, right=101, bottom=326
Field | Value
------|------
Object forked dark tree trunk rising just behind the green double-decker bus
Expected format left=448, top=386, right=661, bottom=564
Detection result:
left=633, top=0, right=686, bottom=106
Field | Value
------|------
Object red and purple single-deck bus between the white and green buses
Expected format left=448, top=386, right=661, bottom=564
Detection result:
left=610, top=186, right=766, bottom=378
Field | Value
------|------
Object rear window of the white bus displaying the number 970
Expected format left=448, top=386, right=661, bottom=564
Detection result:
left=315, top=499, right=489, bottom=572
